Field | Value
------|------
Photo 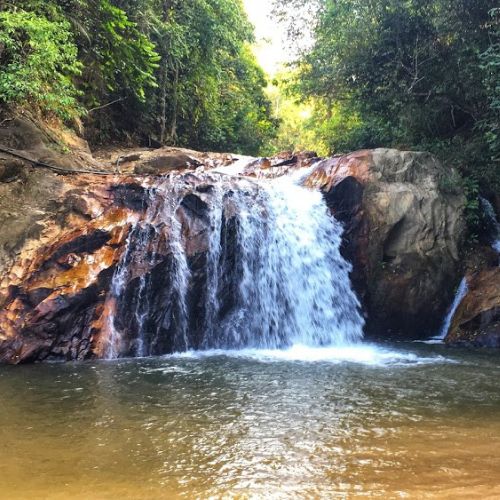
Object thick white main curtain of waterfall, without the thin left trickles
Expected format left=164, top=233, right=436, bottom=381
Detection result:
left=195, top=166, right=364, bottom=349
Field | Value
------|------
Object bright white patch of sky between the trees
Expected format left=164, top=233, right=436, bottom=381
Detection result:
left=244, top=0, right=288, bottom=76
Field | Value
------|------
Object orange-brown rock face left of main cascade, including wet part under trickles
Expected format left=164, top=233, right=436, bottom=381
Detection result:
left=0, top=166, right=255, bottom=363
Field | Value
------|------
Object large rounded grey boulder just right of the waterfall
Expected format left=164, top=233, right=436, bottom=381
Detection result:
left=306, top=149, right=465, bottom=338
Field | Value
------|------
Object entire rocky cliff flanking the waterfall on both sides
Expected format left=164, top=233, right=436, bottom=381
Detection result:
left=0, top=120, right=470, bottom=363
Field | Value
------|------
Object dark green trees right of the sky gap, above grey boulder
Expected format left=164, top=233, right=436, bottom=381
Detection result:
left=275, top=0, right=500, bottom=190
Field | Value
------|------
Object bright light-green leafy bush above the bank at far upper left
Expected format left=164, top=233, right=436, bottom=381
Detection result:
left=0, top=9, right=82, bottom=119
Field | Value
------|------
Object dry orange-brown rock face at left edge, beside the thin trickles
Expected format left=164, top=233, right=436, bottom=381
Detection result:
left=0, top=172, right=138, bottom=363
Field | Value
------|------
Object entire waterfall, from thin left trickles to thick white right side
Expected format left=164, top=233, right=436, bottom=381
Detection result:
left=107, top=173, right=364, bottom=358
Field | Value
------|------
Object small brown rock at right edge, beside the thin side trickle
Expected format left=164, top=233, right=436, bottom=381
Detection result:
left=446, top=267, right=500, bottom=347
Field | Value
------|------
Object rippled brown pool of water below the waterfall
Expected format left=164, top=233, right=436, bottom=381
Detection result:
left=0, top=344, right=500, bottom=499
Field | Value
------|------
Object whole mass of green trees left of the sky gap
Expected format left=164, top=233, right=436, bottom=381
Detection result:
left=0, top=0, right=276, bottom=154
